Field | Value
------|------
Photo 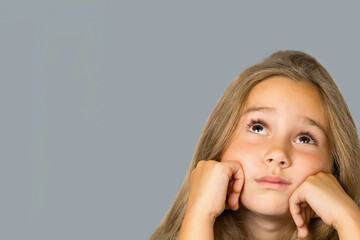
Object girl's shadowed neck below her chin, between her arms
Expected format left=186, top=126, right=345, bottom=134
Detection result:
left=243, top=211, right=294, bottom=240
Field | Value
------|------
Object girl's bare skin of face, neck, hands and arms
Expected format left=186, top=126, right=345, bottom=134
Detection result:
left=179, top=76, right=360, bottom=239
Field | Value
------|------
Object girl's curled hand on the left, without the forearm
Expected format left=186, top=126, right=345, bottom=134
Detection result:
left=187, top=160, right=244, bottom=221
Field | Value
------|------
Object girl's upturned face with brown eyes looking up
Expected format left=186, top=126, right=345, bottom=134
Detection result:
left=222, top=76, right=331, bottom=216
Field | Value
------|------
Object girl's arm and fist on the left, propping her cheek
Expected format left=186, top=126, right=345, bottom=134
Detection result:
left=179, top=160, right=244, bottom=240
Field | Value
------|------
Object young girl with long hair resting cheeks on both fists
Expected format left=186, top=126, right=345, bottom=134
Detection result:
left=150, top=51, right=360, bottom=240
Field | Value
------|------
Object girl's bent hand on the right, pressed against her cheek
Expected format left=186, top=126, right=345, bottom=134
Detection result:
left=289, top=172, right=360, bottom=238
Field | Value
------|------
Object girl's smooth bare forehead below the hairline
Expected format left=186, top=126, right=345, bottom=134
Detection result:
left=241, top=76, right=327, bottom=127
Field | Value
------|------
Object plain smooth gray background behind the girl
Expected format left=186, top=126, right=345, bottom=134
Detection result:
left=0, top=0, right=360, bottom=240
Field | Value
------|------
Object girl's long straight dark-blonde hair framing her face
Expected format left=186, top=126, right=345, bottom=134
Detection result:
left=150, top=51, right=360, bottom=240
